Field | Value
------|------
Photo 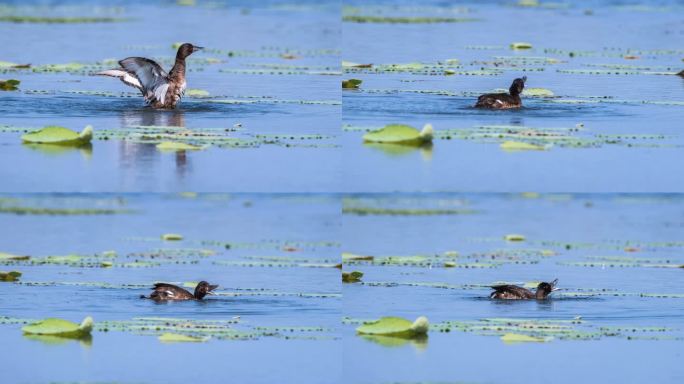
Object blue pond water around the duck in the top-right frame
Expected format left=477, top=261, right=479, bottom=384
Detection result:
left=342, top=1, right=684, bottom=192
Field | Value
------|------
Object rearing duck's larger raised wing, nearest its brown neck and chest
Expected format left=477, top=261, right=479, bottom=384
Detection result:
left=119, top=57, right=169, bottom=104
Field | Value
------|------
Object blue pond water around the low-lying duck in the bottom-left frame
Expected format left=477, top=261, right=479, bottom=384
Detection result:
left=0, top=194, right=341, bottom=383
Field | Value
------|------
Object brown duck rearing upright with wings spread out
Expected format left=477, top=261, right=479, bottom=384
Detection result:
left=96, top=43, right=202, bottom=109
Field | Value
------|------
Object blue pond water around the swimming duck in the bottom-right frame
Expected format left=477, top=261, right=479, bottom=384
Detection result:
left=342, top=194, right=684, bottom=383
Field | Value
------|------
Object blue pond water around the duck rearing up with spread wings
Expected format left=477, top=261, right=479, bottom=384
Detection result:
left=0, top=2, right=340, bottom=192
